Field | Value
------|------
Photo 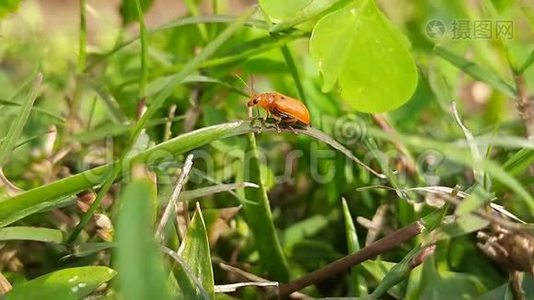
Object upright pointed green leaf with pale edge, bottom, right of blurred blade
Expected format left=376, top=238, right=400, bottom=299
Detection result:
left=176, top=202, right=215, bottom=299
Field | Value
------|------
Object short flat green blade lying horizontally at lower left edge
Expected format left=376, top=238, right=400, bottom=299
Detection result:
left=0, top=226, right=63, bottom=244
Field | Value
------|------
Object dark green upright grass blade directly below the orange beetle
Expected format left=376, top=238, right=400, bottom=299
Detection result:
left=243, top=133, right=289, bottom=281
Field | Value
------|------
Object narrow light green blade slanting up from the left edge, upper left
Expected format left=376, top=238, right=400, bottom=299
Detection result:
left=0, top=74, right=43, bottom=168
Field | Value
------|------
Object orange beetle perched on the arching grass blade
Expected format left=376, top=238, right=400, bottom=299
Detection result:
left=247, top=93, right=310, bottom=131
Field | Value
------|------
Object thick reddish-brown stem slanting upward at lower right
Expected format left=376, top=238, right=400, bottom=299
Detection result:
left=278, top=221, right=424, bottom=297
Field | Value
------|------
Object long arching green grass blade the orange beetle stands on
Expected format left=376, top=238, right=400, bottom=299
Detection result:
left=0, top=121, right=386, bottom=227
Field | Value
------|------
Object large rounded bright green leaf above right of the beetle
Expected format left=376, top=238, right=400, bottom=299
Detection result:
left=310, top=0, right=417, bottom=112
